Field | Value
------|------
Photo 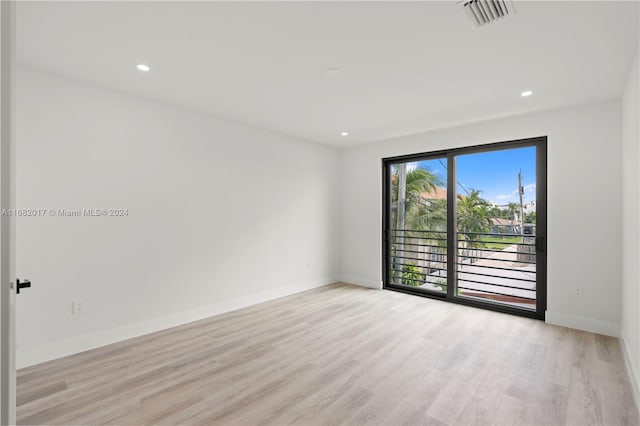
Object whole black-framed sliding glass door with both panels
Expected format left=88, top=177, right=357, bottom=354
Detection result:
left=383, top=138, right=546, bottom=318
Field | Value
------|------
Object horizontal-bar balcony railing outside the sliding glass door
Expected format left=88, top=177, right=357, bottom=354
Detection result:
left=390, top=229, right=536, bottom=309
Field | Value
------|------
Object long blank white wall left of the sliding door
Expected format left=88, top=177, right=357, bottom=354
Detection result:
left=17, top=68, right=340, bottom=366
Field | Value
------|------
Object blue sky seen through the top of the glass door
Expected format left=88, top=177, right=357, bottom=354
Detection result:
left=418, top=147, right=536, bottom=205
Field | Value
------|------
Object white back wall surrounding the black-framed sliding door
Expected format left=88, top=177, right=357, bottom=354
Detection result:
left=341, top=101, right=622, bottom=335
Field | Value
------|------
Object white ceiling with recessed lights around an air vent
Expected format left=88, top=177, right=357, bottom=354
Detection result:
left=17, top=1, right=639, bottom=146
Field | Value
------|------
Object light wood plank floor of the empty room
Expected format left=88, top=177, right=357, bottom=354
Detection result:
left=18, top=284, right=639, bottom=425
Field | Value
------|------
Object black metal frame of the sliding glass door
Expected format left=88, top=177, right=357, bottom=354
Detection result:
left=382, top=136, right=547, bottom=320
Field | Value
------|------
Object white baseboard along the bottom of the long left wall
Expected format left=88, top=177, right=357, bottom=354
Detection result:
left=16, top=279, right=338, bottom=368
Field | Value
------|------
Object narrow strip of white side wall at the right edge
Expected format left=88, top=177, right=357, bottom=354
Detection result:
left=620, top=45, right=640, bottom=404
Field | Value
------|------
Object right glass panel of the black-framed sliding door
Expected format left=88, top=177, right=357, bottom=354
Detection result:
left=455, top=146, right=537, bottom=311
